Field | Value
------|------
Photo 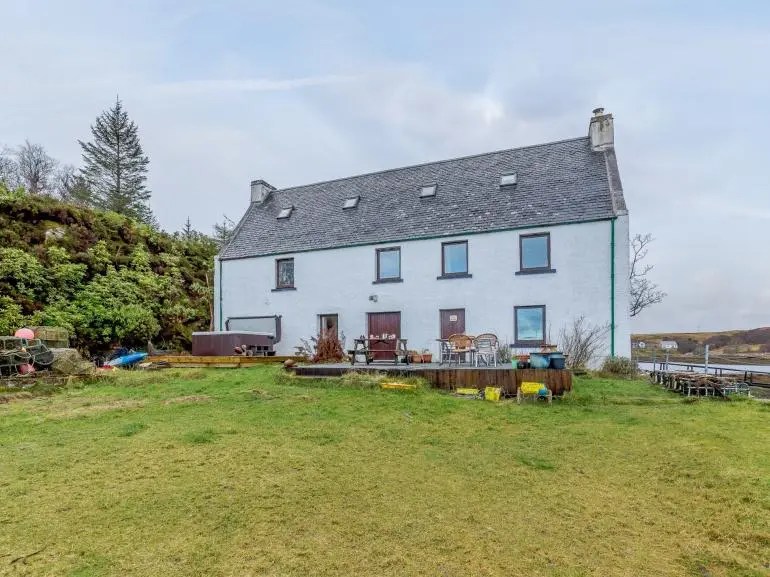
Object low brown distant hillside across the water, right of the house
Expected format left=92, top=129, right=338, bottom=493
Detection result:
left=631, top=327, right=770, bottom=355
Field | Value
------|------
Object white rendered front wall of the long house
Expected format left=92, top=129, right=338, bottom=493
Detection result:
left=215, top=217, right=630, bottom=356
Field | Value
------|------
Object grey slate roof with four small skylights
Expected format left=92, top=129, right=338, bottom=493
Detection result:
left=220, top=137, right=625, bottom=259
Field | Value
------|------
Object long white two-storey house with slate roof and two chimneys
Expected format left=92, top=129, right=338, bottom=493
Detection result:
left=215, top=108, right=631, bottom=356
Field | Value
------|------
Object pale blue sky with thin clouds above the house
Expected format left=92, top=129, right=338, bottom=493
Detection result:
left=0, top=0, right=770, bottom=332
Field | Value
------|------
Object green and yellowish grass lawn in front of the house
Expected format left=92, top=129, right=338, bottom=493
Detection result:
left=0, top=367, right=770, bottom=577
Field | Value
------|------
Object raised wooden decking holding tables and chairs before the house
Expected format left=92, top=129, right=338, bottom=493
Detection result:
left=294, top=363, right=572, bottom=395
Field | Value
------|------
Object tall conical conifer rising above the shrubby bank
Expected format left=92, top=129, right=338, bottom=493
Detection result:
left=78, top=98, right=154, bottom=223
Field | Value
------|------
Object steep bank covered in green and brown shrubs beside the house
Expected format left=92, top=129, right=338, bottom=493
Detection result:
left=0, top=185, right=217, bottom=352
